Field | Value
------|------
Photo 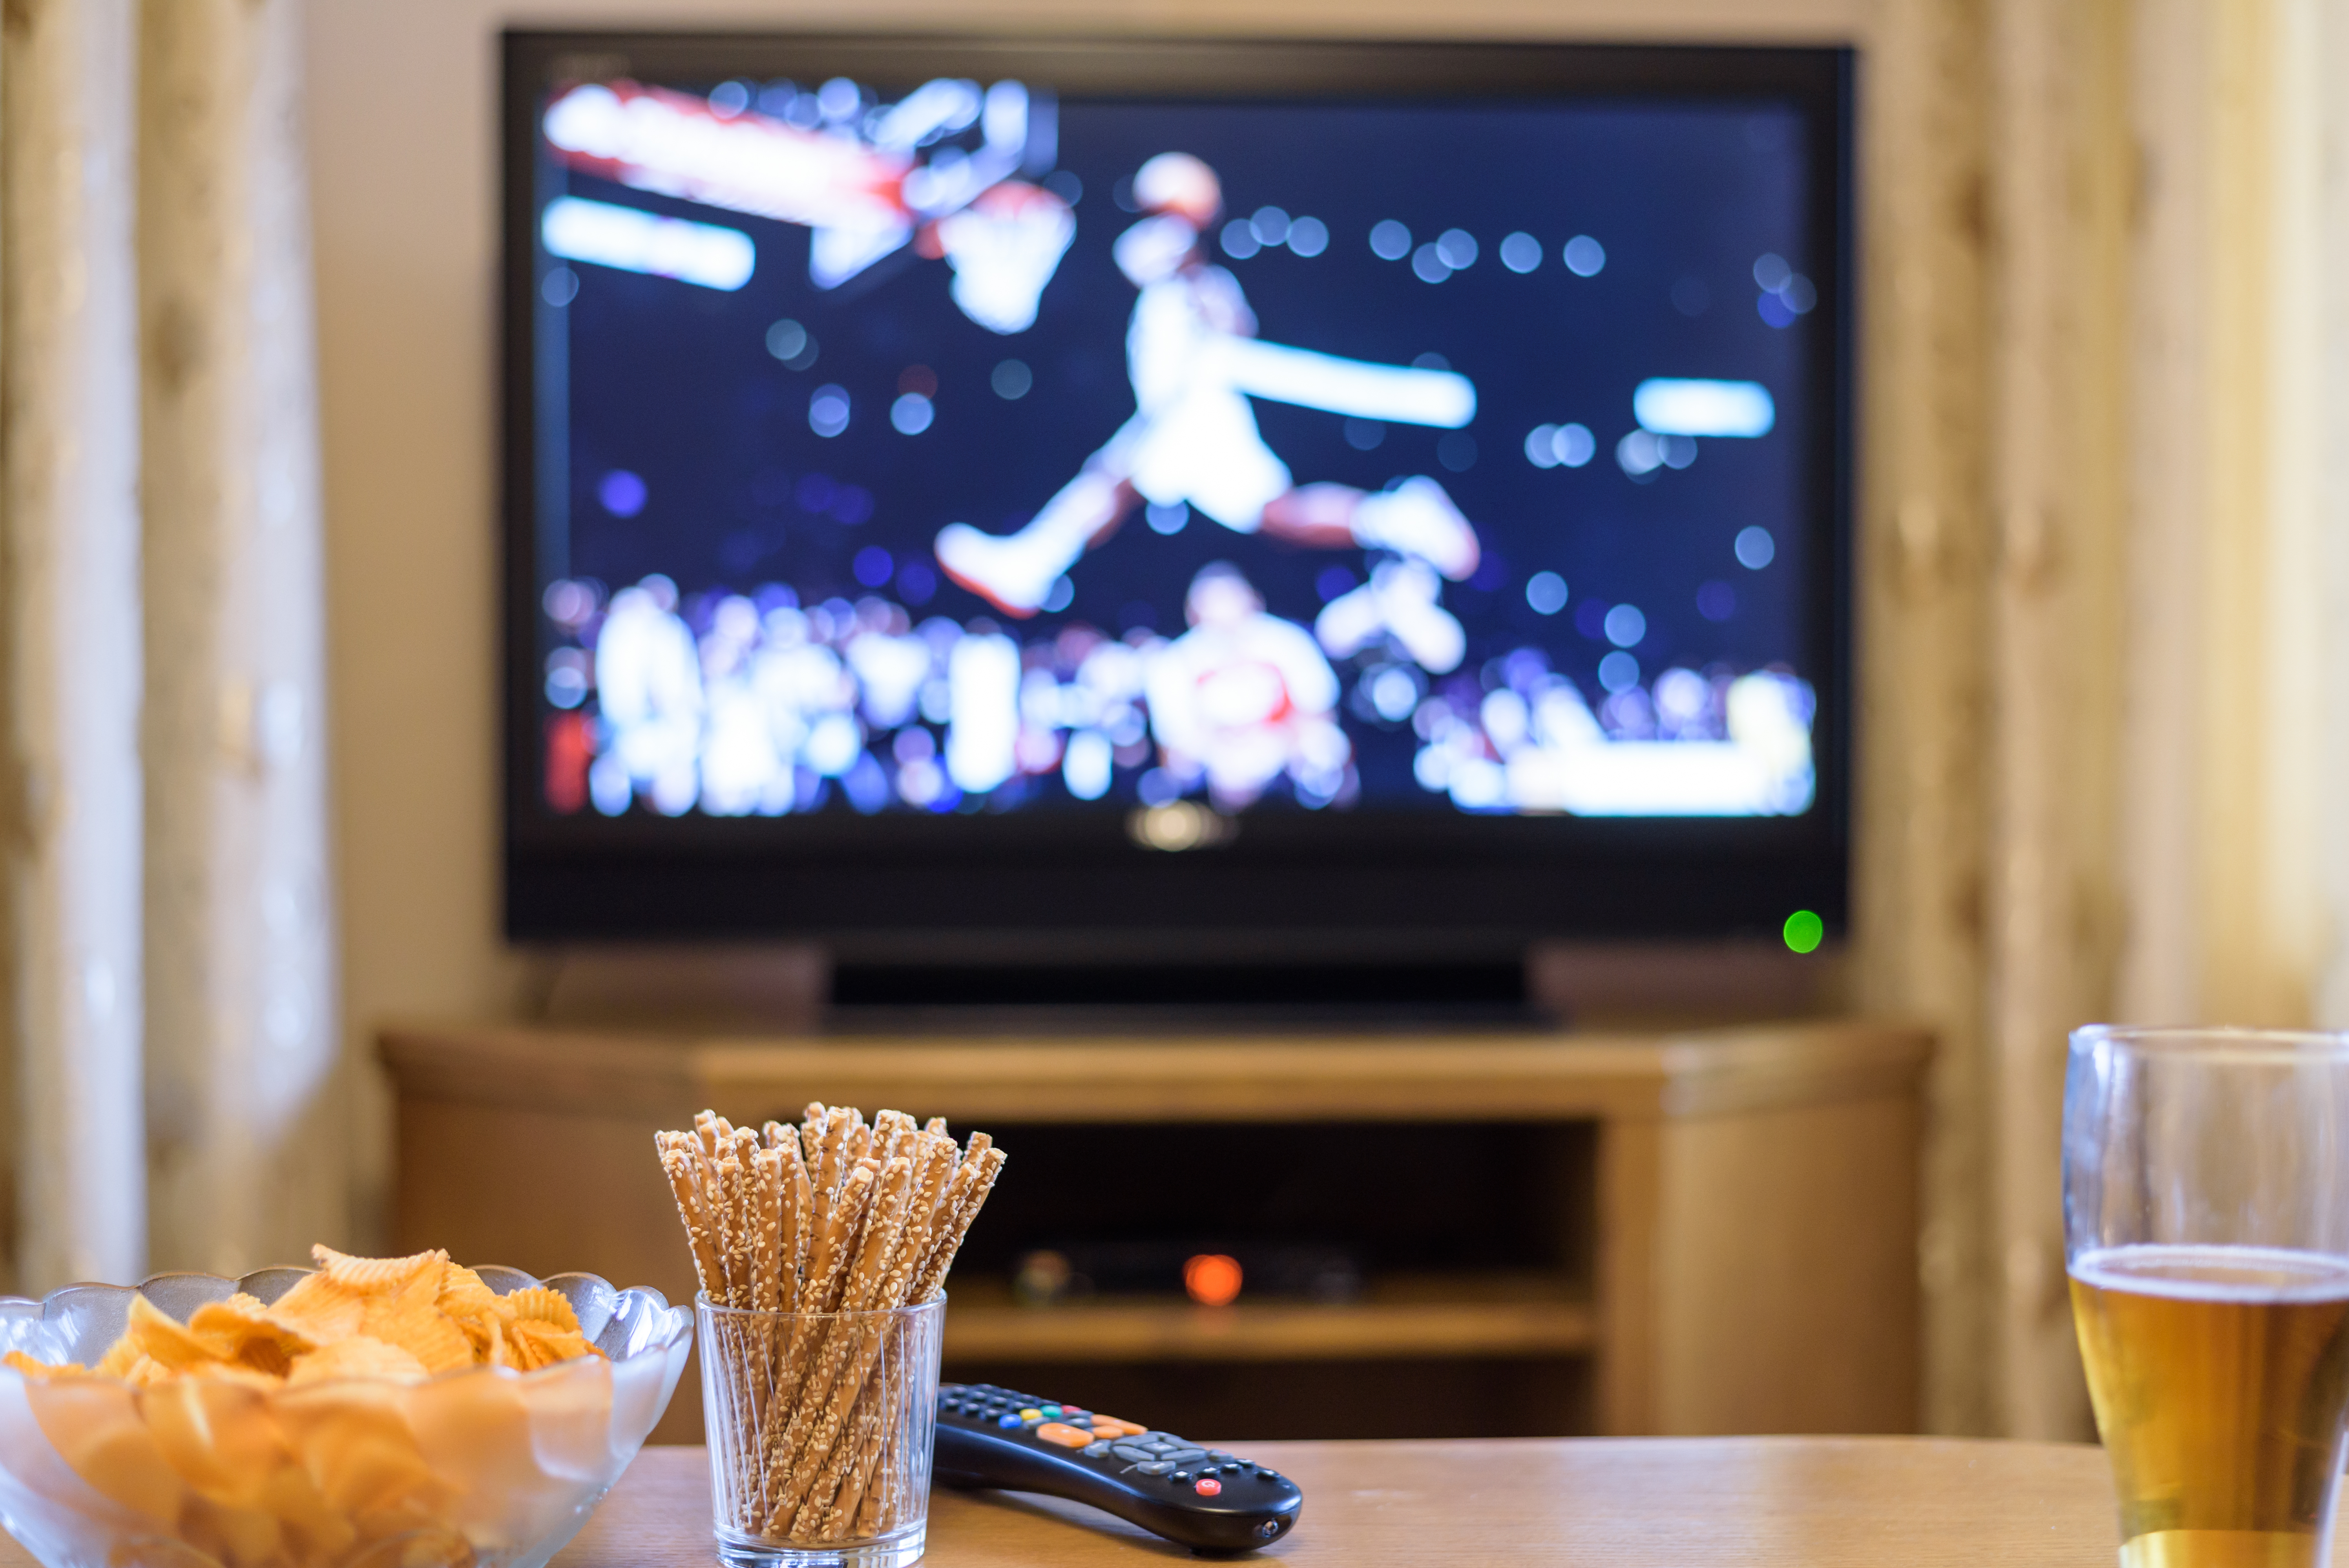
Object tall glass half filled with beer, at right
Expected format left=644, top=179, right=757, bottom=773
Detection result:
left=2062, top=1026, right=2349, bottom=1568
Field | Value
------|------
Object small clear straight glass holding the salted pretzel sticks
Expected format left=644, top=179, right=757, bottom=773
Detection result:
left=695, top=1293, right=947, bottom=1568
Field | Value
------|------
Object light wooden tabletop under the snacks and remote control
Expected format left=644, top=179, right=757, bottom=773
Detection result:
left=552, top=1437, right=2119, bottom=1568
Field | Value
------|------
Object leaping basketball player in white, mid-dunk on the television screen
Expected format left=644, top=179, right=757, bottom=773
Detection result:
left=937, top=153, right=1478, bottom=617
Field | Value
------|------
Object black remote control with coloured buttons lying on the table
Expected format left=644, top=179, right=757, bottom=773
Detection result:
left=933, top=1383, right=1306, bottom=1554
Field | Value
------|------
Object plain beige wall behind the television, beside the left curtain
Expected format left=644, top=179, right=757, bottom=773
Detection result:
left=308, top=0, right=1870, bottom=1239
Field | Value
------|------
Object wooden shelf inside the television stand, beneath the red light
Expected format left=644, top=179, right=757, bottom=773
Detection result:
left=944, top=1277, right=1597, bottom=1366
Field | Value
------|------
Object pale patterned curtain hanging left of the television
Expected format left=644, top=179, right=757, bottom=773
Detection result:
left=0, top=0, right=348, bottom=1291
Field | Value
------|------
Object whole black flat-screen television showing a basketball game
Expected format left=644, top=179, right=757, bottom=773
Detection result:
left=503, top=33, right=1853, bottom=962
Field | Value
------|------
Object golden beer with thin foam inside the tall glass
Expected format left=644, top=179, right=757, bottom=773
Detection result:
left=2072, top=1247, right=2349, bottom=1568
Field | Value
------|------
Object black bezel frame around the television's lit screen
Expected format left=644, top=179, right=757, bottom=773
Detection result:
left=500, top=31, right=1856, bottom=962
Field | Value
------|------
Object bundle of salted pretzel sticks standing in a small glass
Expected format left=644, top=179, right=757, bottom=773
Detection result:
left=655, top=1101, right=1003, bottom=1542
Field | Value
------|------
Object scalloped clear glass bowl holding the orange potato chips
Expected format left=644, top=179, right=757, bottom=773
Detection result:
left=0, top=1265, right=693, bottom=1568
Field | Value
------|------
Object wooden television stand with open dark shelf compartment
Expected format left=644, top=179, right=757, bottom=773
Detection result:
left=381, top=1021, right=1931, bottom=1441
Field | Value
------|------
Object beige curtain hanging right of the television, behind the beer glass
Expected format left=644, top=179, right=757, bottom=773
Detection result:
left=1856, top=0, right=2349, bottom=1437
